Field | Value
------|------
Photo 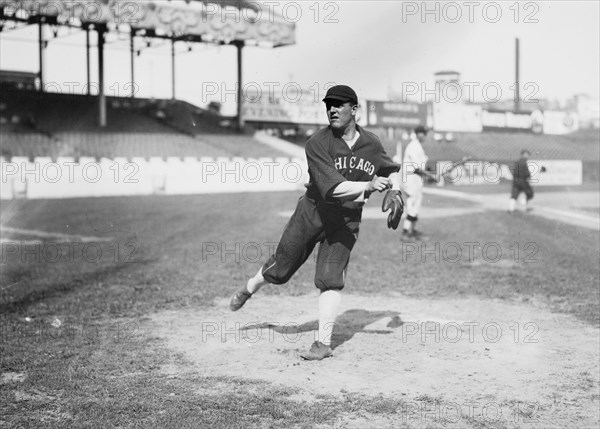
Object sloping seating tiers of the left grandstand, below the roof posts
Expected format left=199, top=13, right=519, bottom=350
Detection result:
left=0, top=88, right=296, bottom=160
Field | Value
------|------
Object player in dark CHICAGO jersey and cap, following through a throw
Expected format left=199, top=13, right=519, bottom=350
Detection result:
left=230, top=85, right=401, bottom=360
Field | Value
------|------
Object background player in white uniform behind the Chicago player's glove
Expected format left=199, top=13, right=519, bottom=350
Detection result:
left=402, top=126, right=428, bottom=237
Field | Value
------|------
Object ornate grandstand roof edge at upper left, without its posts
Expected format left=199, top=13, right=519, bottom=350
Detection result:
left=0, top=0, right=295, bottom=47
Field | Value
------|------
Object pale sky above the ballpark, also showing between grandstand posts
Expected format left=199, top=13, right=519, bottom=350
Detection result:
left=0, top=0, right=600, bottom=113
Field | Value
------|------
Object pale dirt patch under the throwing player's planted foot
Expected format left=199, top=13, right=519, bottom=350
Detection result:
left=152, top=295, right=600, bottom=427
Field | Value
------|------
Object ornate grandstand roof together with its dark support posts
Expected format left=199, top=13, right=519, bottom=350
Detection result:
left=0, top=0, right=295, bottom=129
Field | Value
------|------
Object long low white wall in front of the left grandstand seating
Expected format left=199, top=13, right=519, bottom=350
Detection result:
left=0, top=157, right=308, bottom=199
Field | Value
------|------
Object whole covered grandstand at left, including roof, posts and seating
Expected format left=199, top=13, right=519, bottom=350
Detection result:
left=0, top=0, right=294, bottom=161
